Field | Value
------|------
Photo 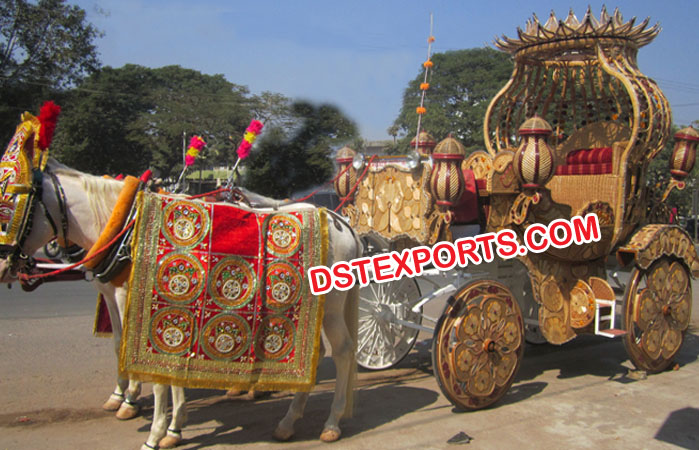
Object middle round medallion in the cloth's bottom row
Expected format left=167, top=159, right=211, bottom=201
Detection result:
left=201, top=314, right=251, bottom=360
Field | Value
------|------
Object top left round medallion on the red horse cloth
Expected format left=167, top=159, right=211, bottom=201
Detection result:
left=162, top=200, right=209, bottom=247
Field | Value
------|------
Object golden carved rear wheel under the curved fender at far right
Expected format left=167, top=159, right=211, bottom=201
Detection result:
left=624, top=257, right=692, bottom=373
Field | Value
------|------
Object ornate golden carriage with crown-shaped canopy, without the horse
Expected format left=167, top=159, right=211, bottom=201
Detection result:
left=335, top=10, right=699, bottom=409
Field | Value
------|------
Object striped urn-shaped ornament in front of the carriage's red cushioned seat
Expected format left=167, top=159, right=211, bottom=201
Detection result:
left=513, top=116, right=555, bottom=189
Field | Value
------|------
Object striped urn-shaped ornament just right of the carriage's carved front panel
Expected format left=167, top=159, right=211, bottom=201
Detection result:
left=430, top=135, right=466, bottom=209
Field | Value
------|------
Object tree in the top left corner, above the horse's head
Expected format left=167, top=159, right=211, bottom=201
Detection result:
left=0, top=0, right=101, bottom=142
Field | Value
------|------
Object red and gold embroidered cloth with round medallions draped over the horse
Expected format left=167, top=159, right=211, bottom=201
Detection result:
left=120, top=193, right=327, bottom=390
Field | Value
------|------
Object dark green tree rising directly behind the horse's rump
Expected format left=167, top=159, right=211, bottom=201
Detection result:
left=244, top=101, right=358, bottom=198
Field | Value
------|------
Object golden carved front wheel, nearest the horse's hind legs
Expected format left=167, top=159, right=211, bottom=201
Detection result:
left=432, top=280, right=524, bottom=410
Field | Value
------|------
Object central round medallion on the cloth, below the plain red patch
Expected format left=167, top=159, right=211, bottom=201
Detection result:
left=209, top=256, right=257, bottom=308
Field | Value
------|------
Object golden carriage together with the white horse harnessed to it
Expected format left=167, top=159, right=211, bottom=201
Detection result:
left=0, top=4, right=699, bottom=448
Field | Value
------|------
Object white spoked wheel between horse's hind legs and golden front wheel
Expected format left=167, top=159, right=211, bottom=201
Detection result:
left=357, top=278, right=422, bottom=370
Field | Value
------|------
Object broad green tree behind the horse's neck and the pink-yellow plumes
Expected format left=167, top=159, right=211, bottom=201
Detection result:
left=52, top=65, right=251, bottom=177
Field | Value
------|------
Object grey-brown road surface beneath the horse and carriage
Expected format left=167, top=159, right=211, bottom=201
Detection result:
left=0, top=268, right=699, bottom=449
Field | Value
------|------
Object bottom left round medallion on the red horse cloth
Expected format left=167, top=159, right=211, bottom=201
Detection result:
left=150, top=307, right=195, bottom=355
